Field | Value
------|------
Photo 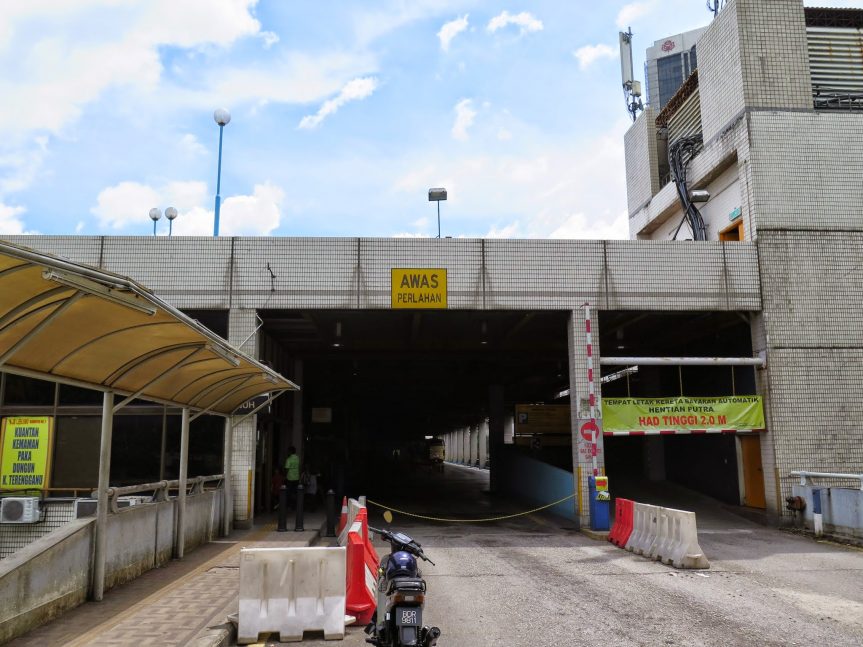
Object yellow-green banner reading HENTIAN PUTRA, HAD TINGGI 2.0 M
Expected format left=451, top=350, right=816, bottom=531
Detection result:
left=602, top=395, right=764, bottom=433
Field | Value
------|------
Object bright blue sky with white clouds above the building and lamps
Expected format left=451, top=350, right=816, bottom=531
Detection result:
left=0, top=0, right=863, bottom=238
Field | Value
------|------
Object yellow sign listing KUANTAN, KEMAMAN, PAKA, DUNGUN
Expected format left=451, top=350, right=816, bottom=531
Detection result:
left=0, top=416, right=54, bottom=490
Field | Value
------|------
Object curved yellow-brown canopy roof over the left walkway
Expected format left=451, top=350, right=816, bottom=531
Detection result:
left=0, top=240, right=299, bottom=415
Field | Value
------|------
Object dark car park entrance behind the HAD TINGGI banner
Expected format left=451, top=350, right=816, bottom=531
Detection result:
left=600, top=311, right=763, bottom=507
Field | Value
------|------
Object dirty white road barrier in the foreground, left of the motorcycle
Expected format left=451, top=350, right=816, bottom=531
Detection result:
left=237, top=548, right=346, bottom=645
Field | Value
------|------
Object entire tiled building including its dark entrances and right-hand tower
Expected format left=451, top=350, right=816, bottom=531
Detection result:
left=0, top=0, right=863, bottom=523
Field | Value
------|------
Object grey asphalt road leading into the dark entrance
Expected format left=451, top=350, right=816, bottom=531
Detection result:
left=245, top=466, right=863, bottom=647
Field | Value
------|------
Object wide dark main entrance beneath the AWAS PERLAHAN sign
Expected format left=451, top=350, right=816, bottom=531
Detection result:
left=256, top=310, right=572, bottom=507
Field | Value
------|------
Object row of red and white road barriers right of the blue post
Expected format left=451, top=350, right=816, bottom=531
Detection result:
left=608, top=499, right=710, bottom=568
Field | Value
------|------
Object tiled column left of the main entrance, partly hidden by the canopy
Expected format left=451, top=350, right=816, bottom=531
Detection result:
left=228, top=308, right=258, bottom=528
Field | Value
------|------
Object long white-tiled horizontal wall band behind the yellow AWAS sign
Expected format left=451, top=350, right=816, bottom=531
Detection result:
left=3, top=236, right=760, bottom=314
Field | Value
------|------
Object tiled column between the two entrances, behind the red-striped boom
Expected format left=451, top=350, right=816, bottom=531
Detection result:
left=567, top=307, right=614, bottom=527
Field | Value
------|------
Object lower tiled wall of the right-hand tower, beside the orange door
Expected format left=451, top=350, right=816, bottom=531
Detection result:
left=758, top=230, right=863, bottom=508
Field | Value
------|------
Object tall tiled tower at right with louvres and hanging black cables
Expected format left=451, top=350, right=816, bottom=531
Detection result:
left=625, top=0, right=863, bottom=512
